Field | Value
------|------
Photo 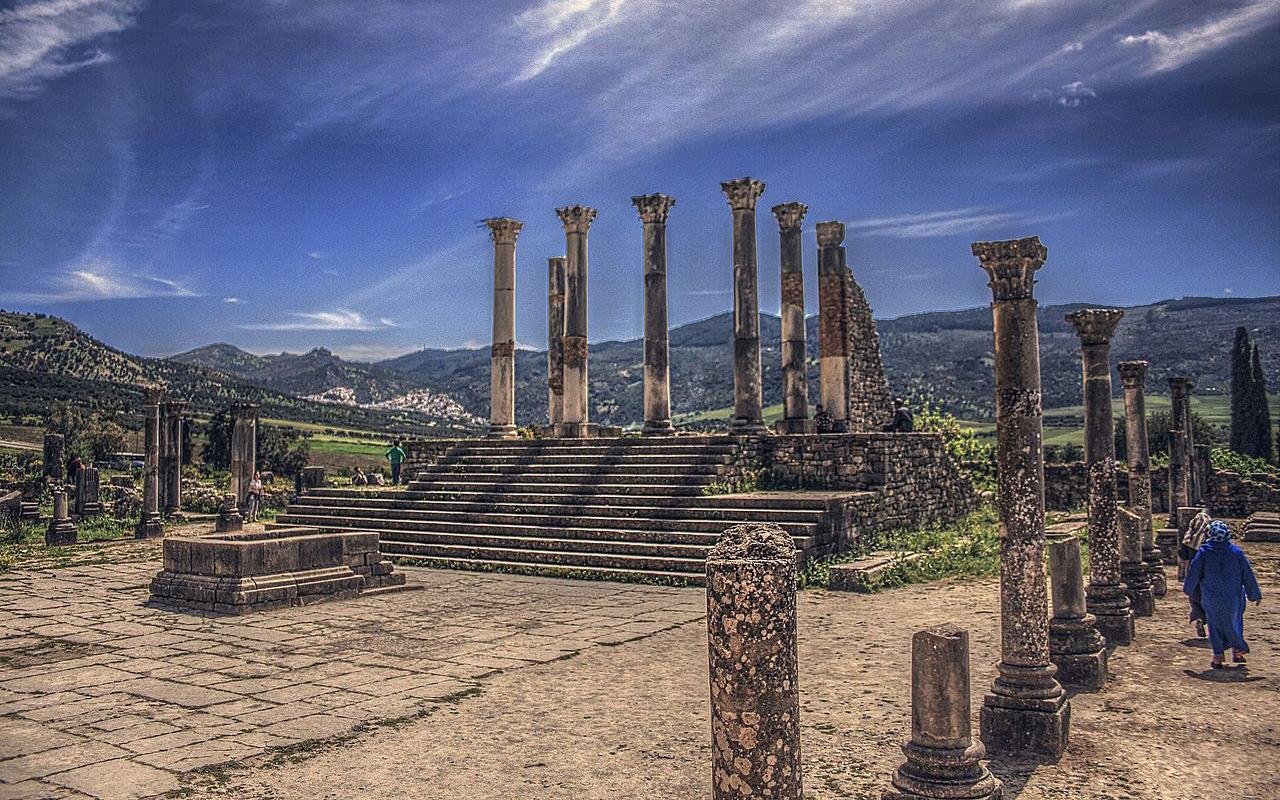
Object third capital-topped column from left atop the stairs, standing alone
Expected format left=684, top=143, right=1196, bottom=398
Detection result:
left=631, top=195, right=676, bottom=436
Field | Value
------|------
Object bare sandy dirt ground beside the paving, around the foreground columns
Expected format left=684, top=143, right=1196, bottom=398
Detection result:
left=185, top=547, right=1280, bottom=800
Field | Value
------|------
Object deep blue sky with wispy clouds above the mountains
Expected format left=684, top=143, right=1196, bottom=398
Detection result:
left=0, top=0, right=1280, bottom=358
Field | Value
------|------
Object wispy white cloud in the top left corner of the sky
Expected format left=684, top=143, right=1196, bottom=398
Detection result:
left=0, top=0, right=141, bottom=101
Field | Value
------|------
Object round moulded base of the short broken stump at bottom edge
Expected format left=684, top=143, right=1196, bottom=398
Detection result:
left=881, top=741, right=1002, bottom=800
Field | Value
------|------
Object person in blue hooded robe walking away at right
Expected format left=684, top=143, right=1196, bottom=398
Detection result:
left=1183, top=520, right=1262, bottom=669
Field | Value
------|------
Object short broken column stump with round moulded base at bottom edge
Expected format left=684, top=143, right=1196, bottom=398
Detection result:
left=883, top=626, right=1001, bottom=800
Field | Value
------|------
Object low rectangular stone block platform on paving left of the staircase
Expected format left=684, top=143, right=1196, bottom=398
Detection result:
left=151, top=527, right=404, bottom=614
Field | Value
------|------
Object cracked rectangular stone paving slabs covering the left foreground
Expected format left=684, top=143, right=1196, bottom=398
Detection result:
left=0, top=555, right=703, bottom=797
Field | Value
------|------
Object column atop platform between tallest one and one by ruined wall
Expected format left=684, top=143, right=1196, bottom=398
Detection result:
left=773, top=202, right=814, bottom=434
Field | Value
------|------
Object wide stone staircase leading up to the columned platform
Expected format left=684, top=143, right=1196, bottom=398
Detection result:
left=276, top=436, right=865, bottom=584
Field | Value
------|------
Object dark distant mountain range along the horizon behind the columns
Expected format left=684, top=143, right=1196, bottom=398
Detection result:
left=0, top=291, right=1280, bottom=433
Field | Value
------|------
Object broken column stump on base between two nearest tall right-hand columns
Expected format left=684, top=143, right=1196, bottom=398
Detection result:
left=1048, top=536, right=1107, bottom=691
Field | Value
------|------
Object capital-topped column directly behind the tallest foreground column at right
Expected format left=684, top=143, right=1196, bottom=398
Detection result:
left=1066, top=308, right=1133, bottom=645
